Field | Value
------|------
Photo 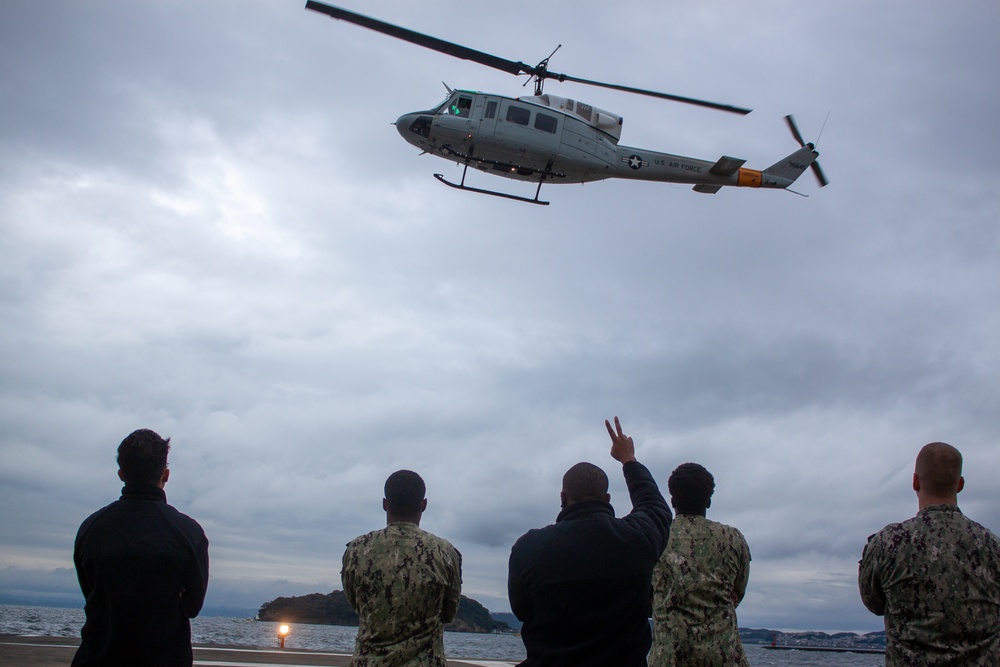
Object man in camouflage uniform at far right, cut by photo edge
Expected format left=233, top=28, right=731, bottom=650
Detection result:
left=858, top=442, right=1000, bottom=667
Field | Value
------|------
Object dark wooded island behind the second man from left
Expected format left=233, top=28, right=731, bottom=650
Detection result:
left=257, top=591, right=511, bottom=632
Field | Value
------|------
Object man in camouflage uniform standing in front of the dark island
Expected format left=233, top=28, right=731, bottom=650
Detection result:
left=340, top=470, right=462, bottom=667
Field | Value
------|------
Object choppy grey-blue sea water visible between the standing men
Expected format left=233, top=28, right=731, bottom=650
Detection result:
left=0, top=605, right=885, bottom=667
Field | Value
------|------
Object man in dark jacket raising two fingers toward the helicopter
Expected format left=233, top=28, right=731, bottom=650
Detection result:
left=507, top=417, right=671, bottom=667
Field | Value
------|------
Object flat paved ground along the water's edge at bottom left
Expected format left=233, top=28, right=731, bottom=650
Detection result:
left=0, top=635, right=516, bottom=667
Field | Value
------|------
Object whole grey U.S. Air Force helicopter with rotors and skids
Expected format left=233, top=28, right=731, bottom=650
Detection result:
left=305, top=0, right=828, bottom=206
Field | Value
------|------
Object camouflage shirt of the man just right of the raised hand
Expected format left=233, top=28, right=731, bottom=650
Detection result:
left=649, top=514, right=750, bottom=667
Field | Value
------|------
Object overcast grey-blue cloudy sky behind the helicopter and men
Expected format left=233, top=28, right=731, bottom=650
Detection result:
left=0, top=0, right=1000, bottom=631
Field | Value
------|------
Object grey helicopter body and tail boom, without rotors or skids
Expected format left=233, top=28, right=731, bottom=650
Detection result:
left=396, top=90, right=815, bottom=192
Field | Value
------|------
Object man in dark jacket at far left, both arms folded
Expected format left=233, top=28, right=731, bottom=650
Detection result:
left=73, top=429, right=208, bottom=667
